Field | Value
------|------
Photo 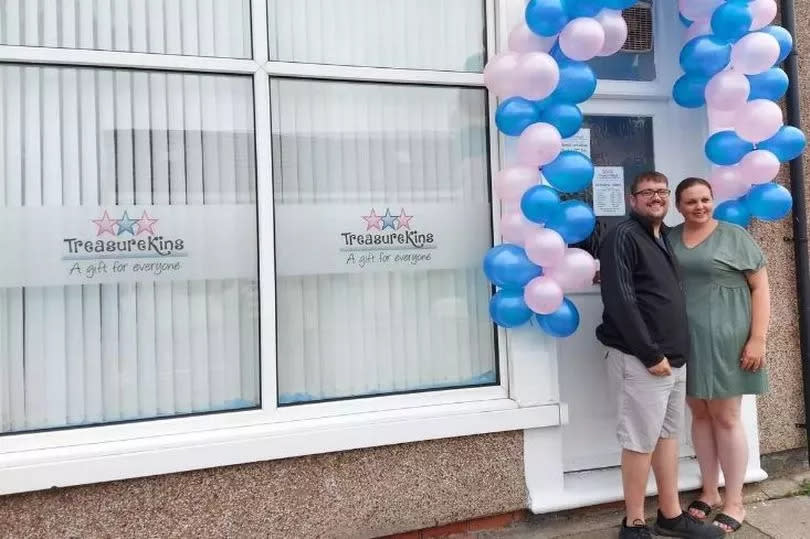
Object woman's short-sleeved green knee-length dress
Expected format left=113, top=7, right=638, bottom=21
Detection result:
left=669, top=222, right=768, bottom=399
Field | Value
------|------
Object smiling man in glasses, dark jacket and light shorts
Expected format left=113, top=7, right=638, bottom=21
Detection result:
left=596, top=172, right=723, bottom=539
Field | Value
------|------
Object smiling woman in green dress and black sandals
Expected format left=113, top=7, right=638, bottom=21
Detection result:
left=670, top=178, right=770, bottom=533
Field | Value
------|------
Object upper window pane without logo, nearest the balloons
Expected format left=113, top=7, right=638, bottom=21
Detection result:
left=267, top=0, right=486, bottom=72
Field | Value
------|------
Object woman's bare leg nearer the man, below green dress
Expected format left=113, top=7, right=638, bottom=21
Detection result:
left=686, top=397, right=721, bottom=519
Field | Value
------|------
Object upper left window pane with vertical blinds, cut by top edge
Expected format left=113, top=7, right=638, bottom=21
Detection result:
left=0, top=0, right=251, bottom=58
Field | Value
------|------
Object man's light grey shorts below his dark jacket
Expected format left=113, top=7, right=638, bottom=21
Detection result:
left=607, top=348, right=686, bottom=453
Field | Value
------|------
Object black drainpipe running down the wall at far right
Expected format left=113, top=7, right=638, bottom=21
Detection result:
left=780, top=0, right=810, bottom=462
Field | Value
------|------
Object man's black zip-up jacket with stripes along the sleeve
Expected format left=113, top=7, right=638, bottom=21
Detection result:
left=596, top=214, right=689, bottom=367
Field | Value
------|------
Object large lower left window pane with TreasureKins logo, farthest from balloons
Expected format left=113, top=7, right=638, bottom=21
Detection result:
left=0, top=65, right=259, bottom=432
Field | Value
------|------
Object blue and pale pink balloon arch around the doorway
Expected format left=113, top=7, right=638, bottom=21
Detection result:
left=483, top=0, right=805, bottom=338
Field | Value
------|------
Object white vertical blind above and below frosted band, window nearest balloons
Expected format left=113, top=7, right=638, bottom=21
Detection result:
left=271, top=80, right=496, bottom=404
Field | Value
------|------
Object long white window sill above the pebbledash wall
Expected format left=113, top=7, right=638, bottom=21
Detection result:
left=0, top=399, right=564, bottom=495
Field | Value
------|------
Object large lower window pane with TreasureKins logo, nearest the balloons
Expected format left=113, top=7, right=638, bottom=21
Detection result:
left=271, top=79, right=497, bottom=404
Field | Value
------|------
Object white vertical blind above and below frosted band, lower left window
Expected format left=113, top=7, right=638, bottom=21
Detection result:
left=0, top=64, right=259, bottom=432
